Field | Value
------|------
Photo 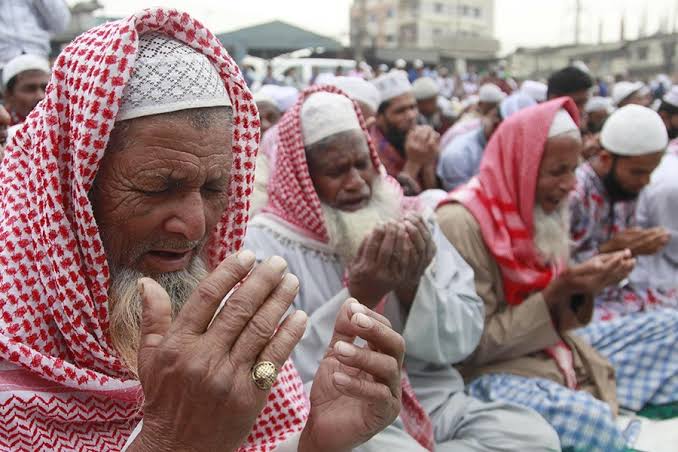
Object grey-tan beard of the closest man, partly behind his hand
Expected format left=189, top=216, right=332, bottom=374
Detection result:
left=108, top=257, right=207, bottom=377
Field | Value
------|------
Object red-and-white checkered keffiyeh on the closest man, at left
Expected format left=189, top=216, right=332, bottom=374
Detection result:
left=0, top=9, right=308, bottom=451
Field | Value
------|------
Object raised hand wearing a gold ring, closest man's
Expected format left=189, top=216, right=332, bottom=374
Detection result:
left=129, top=251, right=307, bottom=451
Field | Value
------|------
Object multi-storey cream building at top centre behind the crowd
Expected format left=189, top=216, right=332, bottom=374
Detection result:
left=350, top=0, right=499, bottom=69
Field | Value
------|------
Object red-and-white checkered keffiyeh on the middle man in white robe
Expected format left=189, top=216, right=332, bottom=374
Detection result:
left=264, top=85, right=434, bottom=450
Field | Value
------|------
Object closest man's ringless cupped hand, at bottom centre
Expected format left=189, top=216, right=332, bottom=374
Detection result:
left=298, top=299, right=405, bottom=452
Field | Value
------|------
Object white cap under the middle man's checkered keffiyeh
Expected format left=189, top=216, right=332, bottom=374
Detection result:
left=301, top=91, right=362, bottom=146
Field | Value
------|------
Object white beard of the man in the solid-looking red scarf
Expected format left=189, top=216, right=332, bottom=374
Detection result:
left=534, top=201, right=570, bottom=264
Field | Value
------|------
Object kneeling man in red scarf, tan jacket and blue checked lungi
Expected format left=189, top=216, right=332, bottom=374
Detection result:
left=437, top=97, right=676, bottom=452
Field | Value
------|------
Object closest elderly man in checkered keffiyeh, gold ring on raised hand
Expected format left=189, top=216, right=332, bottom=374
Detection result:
left=0, top=9, right=403, bottom=452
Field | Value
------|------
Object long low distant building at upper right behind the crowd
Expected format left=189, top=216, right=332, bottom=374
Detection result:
left=507, top=33, right=678, bottom=78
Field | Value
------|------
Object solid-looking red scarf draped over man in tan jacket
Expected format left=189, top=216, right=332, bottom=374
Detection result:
left=441, top=97, right=579, bottom=387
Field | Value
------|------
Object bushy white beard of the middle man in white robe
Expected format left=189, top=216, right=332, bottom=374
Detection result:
left=322, top=178, right=402, bottom=263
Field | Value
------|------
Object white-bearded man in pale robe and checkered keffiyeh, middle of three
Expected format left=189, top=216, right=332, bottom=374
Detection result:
left=245, top=87, right=558, bottom=452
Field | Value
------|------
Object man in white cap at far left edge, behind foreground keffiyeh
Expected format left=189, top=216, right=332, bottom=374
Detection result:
left=2, top=55, right=50, bottom=126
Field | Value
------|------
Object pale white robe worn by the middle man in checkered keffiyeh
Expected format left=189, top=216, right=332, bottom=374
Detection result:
left=245, top=214, right=559, bottom=451
